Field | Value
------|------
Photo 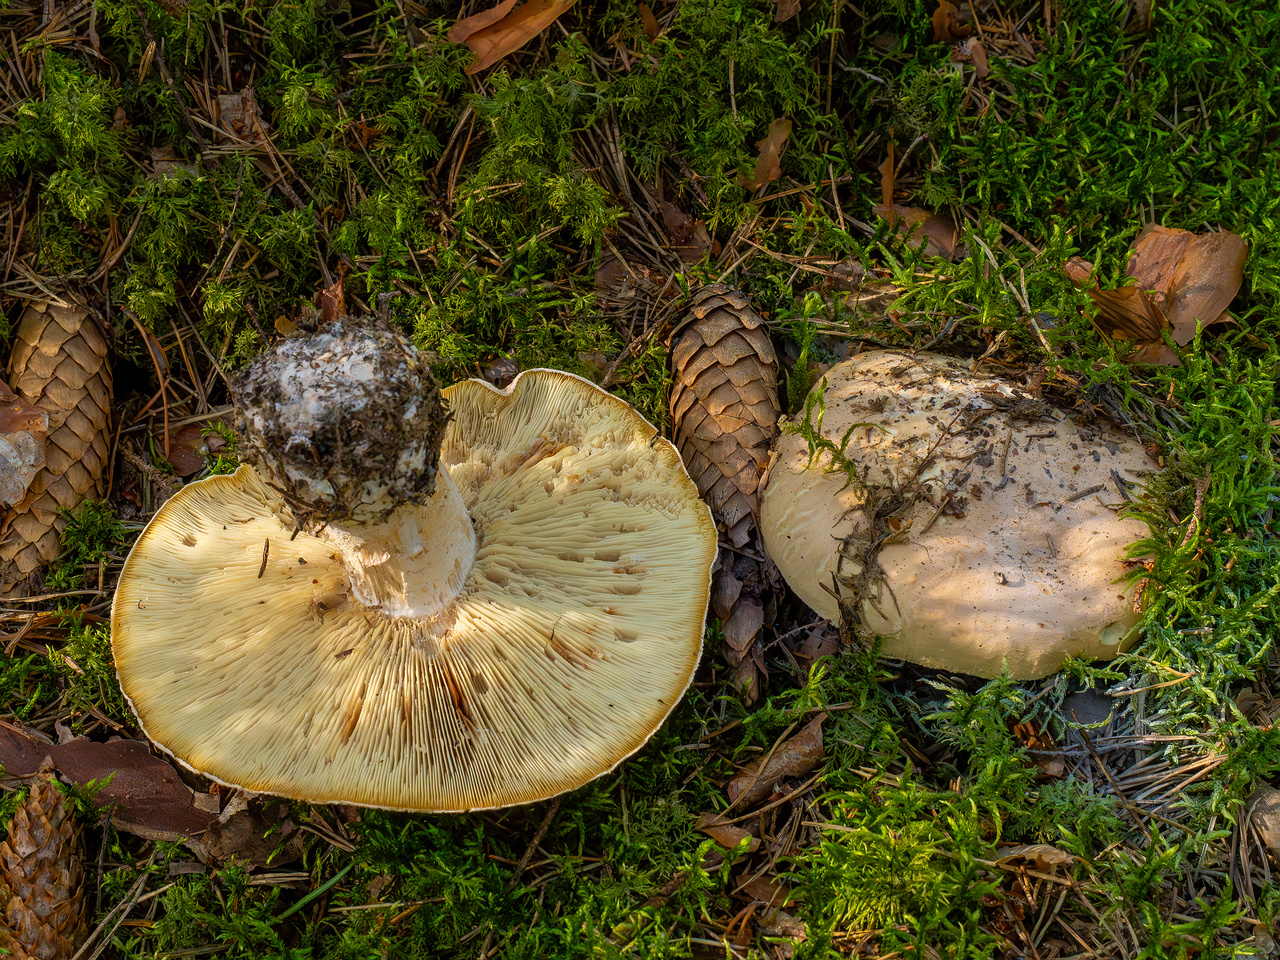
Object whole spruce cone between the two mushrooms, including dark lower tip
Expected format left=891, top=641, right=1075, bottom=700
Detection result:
left=671, top=285, right=778, bottom=701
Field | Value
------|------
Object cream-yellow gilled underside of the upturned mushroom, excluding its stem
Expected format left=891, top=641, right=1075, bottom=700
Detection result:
left=111, top=370, right=716, bottom=812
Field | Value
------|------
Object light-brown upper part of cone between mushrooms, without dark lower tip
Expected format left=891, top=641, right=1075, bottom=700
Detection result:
left=671, top=284, right=778, bottom=548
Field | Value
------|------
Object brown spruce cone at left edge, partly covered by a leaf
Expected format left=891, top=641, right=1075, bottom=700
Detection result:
left=0, top=303, right=111, bottom=596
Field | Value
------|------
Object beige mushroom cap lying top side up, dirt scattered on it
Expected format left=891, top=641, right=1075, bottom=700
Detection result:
left=760, top=351, right=1157, bottom=680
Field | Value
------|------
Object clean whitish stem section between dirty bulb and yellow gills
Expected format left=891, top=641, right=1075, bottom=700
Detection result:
left=320, top=470, right=476, bottom=621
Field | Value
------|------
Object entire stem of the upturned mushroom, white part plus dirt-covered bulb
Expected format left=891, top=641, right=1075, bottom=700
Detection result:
left=233, top=319, right=475, bottom=620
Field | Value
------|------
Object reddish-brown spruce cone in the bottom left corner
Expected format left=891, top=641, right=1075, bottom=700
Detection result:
left=0, top=772, right=86, bottom=960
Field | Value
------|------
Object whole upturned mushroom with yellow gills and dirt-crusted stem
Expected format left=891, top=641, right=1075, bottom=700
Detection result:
left=111, top=320, right=716, bottom=812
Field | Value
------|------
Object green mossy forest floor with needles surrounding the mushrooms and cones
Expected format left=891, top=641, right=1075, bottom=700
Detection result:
left=0, top=0, right=1280, bottom=960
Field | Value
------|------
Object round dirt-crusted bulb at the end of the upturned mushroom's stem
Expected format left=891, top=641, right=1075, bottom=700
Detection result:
left=233, top=320, right=447, bottom=524
